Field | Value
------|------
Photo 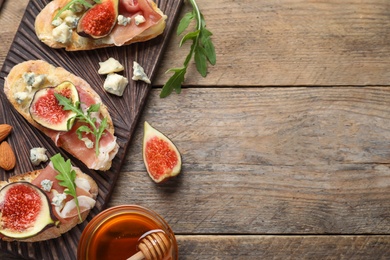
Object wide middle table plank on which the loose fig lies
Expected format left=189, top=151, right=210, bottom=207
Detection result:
left=111, top=87, right=390, bottom=234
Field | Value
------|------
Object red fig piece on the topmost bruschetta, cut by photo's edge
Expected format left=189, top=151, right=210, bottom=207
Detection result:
left=77, top=0, right=119, bottom=39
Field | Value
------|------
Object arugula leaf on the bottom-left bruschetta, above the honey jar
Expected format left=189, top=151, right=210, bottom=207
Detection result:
left=50, top=153, right=83, bottom=222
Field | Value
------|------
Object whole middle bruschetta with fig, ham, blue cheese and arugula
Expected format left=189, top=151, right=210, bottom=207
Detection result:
left=4, top=60, right=119, bottom=171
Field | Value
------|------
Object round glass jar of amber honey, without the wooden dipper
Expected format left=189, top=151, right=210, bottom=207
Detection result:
left=77, top=205, right=178, bottom=260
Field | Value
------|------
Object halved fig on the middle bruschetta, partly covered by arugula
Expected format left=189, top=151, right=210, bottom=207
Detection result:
left=30, top=81, right=79, bottom=131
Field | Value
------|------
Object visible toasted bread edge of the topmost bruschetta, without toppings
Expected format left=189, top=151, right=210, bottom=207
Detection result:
left=34, top=0, right=166, bottom=51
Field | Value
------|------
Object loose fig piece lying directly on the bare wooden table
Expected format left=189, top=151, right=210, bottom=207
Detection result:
left=143, top=121, right=181, bottom=183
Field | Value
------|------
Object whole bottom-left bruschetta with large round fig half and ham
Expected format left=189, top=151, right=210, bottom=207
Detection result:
left=0, top=154, right=98, bottom=242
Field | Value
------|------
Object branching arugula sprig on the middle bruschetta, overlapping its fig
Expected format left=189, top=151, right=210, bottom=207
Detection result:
left=54, top=93, right=108, bottom=155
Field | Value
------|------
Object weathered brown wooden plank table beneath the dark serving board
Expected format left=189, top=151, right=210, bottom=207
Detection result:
left=0, top=0, right=390, bottom=259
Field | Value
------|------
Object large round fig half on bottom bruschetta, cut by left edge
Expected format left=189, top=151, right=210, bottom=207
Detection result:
left=0, top=182, right=56, bottom=239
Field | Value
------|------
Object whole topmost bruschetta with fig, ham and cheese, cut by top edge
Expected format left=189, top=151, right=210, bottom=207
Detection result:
left=35, top=0, right=167, bottom=51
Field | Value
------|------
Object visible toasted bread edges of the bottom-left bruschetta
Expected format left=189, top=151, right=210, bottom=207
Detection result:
left=0, top=167, right=99, bottom=242
